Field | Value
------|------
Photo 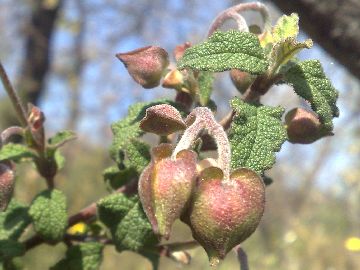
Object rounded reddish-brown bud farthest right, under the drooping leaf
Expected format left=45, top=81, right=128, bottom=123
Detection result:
left=285, top=108, right=321, bottom=144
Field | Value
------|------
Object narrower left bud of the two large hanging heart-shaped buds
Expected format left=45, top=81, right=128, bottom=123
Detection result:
left=139, top=144, right=196, bottom=239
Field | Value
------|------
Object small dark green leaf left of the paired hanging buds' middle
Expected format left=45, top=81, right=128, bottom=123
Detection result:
left=103, top=166, right=139, bottom=189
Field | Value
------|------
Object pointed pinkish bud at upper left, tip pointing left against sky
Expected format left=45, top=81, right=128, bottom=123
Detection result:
left=116, top=46, right=169, bottom=88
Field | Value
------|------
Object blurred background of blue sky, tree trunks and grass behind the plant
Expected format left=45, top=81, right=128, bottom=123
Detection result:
left=0, top=0, right=360, bottom=270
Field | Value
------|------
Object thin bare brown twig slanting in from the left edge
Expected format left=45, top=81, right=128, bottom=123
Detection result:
left=0, top=61, right=28, bottom=127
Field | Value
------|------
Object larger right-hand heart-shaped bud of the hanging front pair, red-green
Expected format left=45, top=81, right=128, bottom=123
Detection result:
left=185, top=167, right=265, bottom=265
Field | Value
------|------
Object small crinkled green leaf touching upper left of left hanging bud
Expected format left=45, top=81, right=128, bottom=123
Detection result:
left=125, top=139, right=151, bottom=174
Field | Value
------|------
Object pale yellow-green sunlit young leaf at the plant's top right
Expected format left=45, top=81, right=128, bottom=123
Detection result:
left=272, top=13, right=299, bottom=43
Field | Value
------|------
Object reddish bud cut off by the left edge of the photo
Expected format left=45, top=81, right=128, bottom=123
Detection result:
left=0, top=162, right=15, bottom=211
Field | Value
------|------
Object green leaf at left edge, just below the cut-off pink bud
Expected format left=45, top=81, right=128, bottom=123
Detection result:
left=0, top=199, right=31, bottom=240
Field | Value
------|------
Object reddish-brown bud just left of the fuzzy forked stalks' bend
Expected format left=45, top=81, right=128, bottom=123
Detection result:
left=140, top=104, right=186, bottom=135
